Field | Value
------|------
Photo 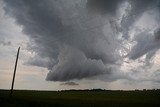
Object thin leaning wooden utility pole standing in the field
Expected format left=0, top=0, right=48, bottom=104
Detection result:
left=10, top=47, right=20, bottom=97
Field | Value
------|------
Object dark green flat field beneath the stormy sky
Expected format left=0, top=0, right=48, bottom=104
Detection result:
left=0, top=90, right=160, bottom=107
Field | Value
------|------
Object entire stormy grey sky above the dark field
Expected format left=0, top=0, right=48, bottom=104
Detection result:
left=0, top=0, right=160, bottom=90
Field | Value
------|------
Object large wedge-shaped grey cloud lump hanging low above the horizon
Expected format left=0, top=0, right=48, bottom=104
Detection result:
left=47, top=47, right=109, bottom=81
